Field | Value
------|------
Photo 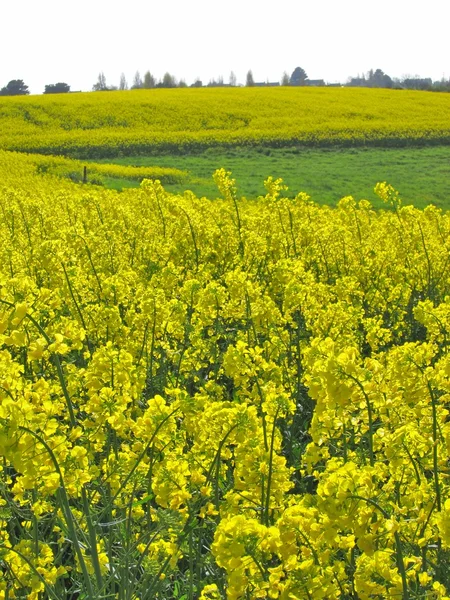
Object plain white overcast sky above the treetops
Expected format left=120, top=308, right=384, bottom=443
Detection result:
left=0, top=0, right=450, bottom=93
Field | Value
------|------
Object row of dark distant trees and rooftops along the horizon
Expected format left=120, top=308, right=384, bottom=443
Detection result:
left=0, top=67, right=450, bottom=96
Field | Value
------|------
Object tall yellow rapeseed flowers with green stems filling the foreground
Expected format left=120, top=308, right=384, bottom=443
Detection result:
left=0, top=146, right=450, bottom=600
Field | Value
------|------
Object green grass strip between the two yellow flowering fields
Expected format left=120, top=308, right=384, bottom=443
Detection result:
left=88, top=146, right=450, bottom=209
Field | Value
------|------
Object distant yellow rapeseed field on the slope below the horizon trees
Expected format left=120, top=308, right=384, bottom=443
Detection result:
left=0, top=87, right=450, bottom=157
